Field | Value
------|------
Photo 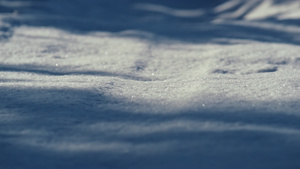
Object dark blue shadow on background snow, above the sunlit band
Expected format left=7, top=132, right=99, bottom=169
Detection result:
left=2, top=0, right=300, bottom=45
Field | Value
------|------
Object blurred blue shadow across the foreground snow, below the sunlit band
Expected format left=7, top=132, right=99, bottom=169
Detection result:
left=0, top=86, right=300, bottom=168
